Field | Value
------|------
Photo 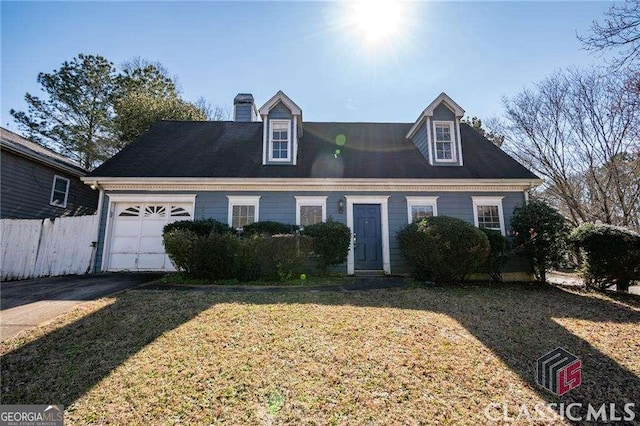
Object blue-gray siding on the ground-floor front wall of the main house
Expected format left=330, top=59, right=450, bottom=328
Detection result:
left=96, top=191, right=524, bottom=274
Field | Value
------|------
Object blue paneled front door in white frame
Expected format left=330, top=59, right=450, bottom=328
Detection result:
left=353, top=204, right=382, bottom=270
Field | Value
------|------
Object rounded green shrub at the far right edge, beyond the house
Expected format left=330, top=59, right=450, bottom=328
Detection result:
left=569, top=223, right=640, bottom=291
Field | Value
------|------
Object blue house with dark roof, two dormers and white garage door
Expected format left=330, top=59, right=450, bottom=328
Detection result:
left=83, top=91, right=541, bottom=274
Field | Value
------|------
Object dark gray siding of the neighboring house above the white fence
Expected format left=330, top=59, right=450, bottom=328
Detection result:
left=0, top=150, right=98, bottom=219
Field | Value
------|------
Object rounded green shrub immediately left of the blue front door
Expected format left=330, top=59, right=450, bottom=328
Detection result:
left=302, top=220, right=351, bottom=273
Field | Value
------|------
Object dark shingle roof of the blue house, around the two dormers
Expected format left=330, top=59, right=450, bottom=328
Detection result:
left=89, top=121, right=537, bottom=179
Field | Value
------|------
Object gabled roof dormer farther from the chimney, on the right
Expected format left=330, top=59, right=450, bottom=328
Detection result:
left=407, top=92, right=464, bottom=166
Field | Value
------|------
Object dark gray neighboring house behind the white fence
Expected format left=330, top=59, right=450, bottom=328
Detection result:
left=0, top=128, right=98, bottom=219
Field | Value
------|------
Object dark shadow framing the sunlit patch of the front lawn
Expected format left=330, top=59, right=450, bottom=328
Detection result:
left=1, top=285, right=640, bottom=419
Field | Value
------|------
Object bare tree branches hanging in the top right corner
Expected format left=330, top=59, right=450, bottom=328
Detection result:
left=578, top=0, right=640, bottom=68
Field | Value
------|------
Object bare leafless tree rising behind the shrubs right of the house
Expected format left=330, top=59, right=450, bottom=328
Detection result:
left=501, top=70, right=640, bottom=228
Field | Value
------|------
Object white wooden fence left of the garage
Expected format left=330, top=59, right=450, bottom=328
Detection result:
left=0, top=215, right=98, bottom=281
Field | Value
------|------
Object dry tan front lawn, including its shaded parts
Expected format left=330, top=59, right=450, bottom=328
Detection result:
left=0, top=285, right=640, bottom=424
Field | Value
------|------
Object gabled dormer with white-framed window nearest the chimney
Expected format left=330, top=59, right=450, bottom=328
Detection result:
left=259, top=90, right=302, bottom=165
